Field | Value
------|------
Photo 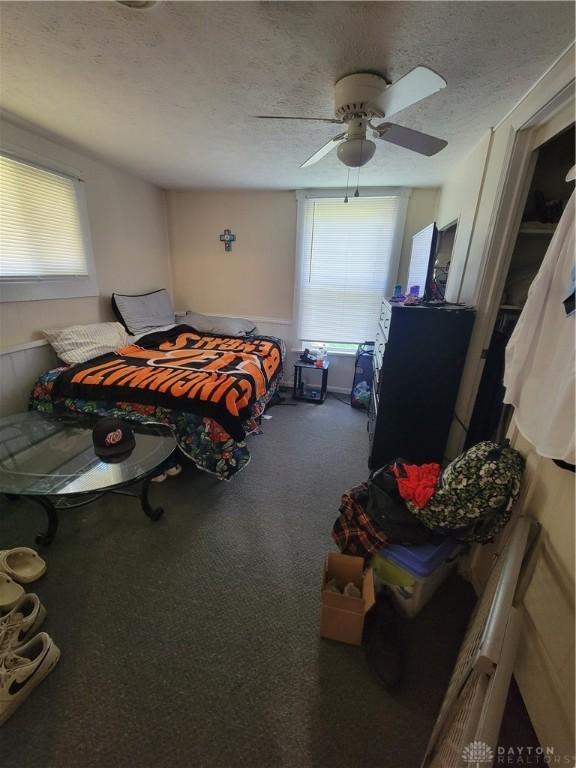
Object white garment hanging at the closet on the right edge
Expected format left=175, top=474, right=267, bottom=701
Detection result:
left=504, top=192, right=576, bottom=464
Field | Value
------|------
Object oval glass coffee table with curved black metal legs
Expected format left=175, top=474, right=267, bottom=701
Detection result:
left=0, top=411, right=176, bottom=545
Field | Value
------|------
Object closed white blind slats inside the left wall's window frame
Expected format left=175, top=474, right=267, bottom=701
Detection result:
left=0, top=155, right=88, bottom=279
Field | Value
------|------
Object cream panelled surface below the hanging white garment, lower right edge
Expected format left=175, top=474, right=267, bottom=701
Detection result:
left=512, top=433, right=575, bottom=755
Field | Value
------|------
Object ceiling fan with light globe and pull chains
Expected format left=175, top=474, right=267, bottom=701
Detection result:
left=257, top=66, right=448, bottom=168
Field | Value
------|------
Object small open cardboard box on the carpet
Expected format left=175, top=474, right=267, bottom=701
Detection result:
left=320, top=552, right=374, bottom=645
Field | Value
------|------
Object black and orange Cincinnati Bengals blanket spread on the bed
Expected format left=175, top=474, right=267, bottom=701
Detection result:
left=53, top=325, right=282, bottom=440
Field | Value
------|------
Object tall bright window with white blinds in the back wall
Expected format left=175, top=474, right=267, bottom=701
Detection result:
left=296, top=190, right=407, bottom=351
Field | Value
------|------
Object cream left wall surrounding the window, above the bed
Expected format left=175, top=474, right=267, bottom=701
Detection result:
left=0, top=121, right=171, bottom=347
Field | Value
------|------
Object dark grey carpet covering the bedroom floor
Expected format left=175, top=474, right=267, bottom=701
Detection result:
left=0, top=397, right=473, bottom=768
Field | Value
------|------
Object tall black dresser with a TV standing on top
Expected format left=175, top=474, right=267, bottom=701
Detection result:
left=368, top=299, right=475, bottom=470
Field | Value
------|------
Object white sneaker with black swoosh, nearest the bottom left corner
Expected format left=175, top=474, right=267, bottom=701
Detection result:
left=0, top=632, right=60, bottom=725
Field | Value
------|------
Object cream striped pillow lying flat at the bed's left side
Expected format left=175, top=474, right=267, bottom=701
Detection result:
left=42, top=323, right=128, bottom=364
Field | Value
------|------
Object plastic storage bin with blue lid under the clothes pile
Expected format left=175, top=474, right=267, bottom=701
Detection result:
left=372, top=539, right=458, bottom=616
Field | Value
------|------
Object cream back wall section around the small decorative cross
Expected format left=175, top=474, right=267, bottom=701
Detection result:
left=167, top=190, right=296, bottom=320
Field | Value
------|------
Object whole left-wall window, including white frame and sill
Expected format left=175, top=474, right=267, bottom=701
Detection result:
left=0, top=153, right=97, bottom=301
